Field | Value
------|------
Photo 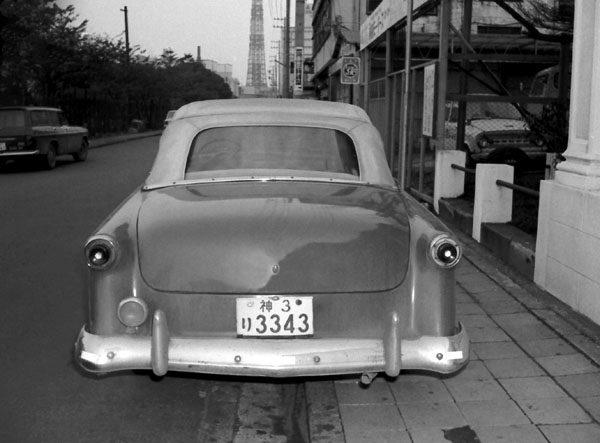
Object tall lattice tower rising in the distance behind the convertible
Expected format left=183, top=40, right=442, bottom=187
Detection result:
left=246, top=0, right=267, bottom=89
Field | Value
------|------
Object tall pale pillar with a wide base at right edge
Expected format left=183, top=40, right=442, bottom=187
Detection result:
left=534, top=0, right=600, bottom=324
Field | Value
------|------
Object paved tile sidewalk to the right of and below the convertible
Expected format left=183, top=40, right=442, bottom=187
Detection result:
left=307, top=231, right=600, bottom=443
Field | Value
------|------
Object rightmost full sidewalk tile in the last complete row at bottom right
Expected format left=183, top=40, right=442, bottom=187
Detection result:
left=515, top=397, right=592, bottom=425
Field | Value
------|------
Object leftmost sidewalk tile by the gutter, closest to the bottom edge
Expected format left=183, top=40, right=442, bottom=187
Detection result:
left=340, top=404, right=406, bottom=439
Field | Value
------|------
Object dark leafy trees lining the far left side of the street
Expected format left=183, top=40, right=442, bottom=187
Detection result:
left=0, top=0, right=232, bottom=133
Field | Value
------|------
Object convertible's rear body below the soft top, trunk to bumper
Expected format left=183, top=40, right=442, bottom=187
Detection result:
left=78, top=180, right=468, bottom=377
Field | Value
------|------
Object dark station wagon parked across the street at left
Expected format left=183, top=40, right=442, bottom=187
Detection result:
left=0, top=106, right=90, bottom=169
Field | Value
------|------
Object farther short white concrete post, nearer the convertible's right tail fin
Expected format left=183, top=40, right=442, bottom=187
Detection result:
left=433, top=149, right=466, bottom=214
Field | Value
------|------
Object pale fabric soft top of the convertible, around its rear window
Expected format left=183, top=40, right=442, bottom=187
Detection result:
left=144, top=98, right=395, bottom=189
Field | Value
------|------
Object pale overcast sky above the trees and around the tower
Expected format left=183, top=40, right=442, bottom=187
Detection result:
left=57, top=0, right=294, bottom=84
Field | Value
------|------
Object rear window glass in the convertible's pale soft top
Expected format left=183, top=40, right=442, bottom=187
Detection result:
left=186, top=126, right=359, bottom=179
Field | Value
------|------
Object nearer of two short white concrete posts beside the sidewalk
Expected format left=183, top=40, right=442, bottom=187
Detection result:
left=473, top=164, right=514, bottom=242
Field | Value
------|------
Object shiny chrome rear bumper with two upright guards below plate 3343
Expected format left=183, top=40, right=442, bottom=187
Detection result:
left=75, top=311, right=469, bottom=377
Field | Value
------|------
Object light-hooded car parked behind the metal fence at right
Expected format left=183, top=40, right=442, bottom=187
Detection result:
left=445, top=96, right=547, bottom=168
